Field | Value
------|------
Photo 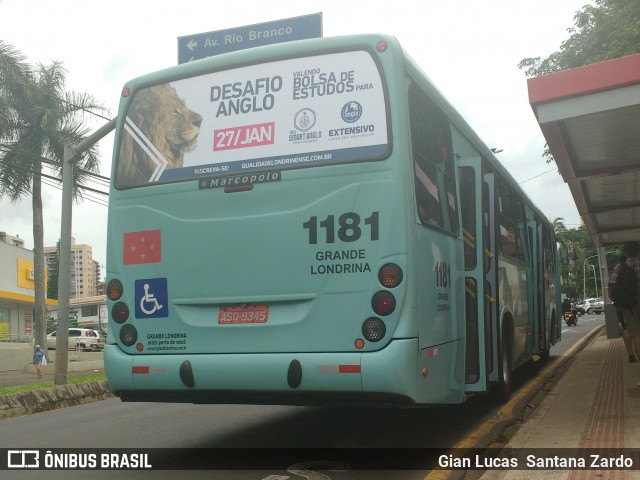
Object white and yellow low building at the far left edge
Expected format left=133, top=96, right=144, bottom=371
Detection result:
left=0, top=232, right=58, bottom=340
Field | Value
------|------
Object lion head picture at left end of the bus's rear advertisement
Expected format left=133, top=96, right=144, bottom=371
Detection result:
left=116, top=83, right=202, bottom=187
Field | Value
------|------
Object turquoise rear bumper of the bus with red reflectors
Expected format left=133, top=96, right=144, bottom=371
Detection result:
left=104, top=339, right=423, bottom=405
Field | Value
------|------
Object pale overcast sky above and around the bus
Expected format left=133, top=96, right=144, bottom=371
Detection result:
left=0, top=0, right=590, bottom=275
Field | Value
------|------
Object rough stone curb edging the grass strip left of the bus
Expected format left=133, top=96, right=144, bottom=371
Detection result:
left=0, top=380, right=114, bottom=420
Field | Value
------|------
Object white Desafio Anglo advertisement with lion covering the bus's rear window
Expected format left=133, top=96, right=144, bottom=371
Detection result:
left=116, top=51, right=389, bottom=187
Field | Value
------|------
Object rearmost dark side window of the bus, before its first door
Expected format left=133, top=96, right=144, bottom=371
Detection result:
left=409, top=84, right=458, bottom=233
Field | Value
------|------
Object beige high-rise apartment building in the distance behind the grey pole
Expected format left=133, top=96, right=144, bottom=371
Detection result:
left=44, top=237, right=100, bottom=298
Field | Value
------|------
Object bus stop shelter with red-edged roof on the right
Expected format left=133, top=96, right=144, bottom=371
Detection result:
left=528, top=54, right=640, bottom=333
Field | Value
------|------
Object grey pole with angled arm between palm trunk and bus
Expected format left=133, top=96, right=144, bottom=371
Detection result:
left=54, top=118, right=116, bottom=385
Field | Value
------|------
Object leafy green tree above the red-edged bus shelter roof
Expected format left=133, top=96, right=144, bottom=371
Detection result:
left=518, top=0, right=640, bottom=77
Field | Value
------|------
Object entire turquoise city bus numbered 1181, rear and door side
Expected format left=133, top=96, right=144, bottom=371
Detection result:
left=105, top=35, right=561, bottom=405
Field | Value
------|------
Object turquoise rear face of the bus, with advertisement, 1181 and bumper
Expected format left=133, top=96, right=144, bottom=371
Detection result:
left=105, top=36, right=460, bottom=404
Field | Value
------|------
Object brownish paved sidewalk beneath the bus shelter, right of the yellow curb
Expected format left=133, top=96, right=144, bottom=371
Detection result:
left=482, top=329, right=640, bottom=480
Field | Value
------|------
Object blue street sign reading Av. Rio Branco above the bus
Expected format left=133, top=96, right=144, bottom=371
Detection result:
left=178, top=13, right=322, bottom=64
